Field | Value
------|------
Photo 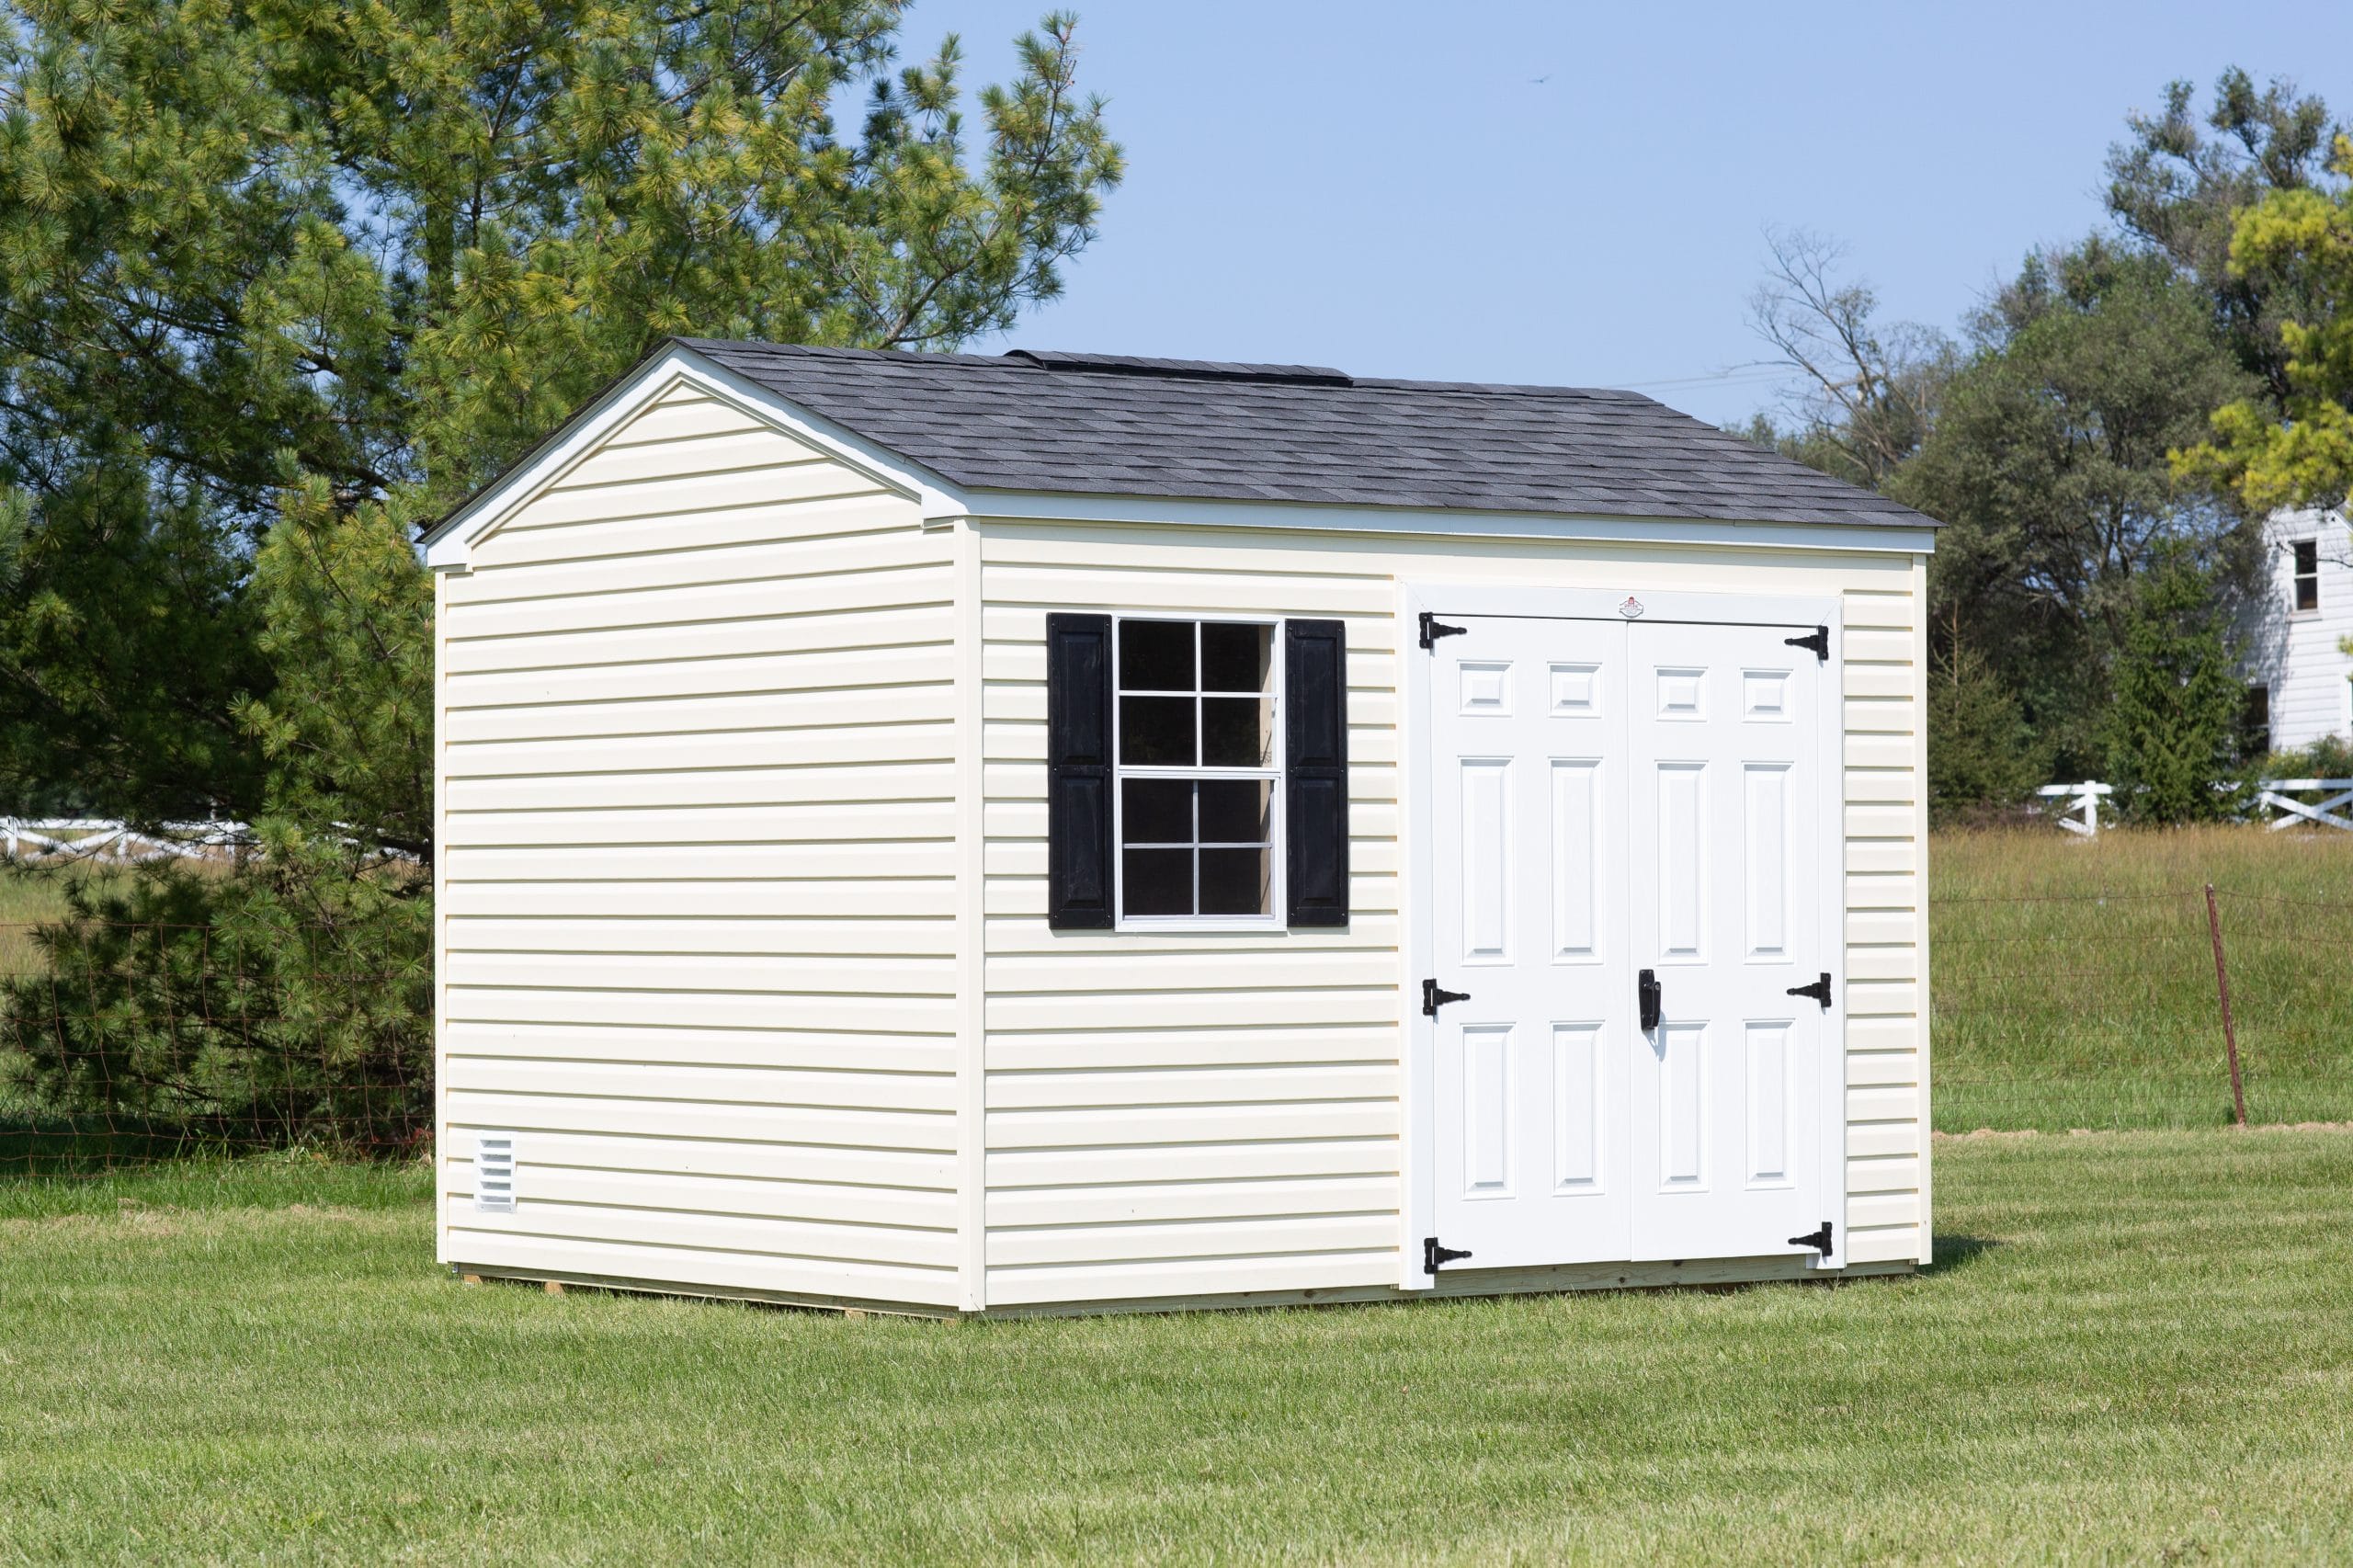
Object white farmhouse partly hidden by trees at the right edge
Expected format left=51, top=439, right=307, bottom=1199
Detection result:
left=2247, top=508, right=2353, bottom=751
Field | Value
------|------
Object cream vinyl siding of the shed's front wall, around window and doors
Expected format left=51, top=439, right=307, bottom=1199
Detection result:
left=979, top=523, right=1927, bottom=1307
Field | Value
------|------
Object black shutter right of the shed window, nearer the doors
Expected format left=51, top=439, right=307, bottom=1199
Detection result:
left=1282, top=621, right=1348, bottom=926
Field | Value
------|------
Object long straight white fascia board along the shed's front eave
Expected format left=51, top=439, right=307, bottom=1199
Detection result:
left=965, top=490, right=1937, bottom=556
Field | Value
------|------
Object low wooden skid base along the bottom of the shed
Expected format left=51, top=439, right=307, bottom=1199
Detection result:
left=454, top=1257, right=1917, bottom=1324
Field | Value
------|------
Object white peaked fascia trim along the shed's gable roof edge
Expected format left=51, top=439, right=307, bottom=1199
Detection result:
left=424, top=344, right=972, bottom=572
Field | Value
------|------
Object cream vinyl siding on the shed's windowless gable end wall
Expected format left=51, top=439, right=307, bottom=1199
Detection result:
left=438, top=386, right=958, bottom=1304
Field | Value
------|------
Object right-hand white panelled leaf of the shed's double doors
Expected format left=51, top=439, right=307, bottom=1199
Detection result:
left=1629, top=624, right=1833, bottom=1259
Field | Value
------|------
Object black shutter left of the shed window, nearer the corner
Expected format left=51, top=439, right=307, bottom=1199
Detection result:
left=1045, top=615, right=1110, bottom=930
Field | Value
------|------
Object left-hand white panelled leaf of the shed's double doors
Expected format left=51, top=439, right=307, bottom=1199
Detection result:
left=1430, top=617, right=1633, bottom=1269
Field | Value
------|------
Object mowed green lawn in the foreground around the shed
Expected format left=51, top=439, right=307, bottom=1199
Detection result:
left=0, top=1131, right=2353, bottom=1563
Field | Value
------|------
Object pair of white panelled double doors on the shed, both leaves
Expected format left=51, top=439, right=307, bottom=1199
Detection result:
left=1428, top=615, right=1842, bottom=1269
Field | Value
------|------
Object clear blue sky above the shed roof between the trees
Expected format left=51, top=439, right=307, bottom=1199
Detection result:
left=901, top=0, right=2353, bottom=424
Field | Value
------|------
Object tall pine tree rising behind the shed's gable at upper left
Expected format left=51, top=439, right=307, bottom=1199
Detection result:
left=0, top=0, right=1120, bottom=819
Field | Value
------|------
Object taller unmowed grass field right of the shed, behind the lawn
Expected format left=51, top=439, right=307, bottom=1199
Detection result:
left=1929, top=826, right=2353, bottom=1132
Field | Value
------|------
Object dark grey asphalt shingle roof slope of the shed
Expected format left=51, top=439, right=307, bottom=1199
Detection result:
left=677, top=339, right=1932, bottom=528
